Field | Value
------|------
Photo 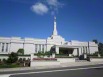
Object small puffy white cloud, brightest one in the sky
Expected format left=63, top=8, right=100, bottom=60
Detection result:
left=31, top=2, right=49, bottom=15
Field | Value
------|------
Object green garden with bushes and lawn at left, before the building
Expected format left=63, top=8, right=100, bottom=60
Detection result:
left=0, top=49, right=30, bottom=68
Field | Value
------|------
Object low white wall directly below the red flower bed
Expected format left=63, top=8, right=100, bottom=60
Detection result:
left=30, top=61, right=60, bottom=67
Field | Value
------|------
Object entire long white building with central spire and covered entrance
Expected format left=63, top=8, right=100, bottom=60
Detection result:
left=0, top=17, right=98, bottom=56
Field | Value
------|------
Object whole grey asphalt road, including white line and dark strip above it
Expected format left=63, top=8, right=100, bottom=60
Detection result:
left=2, top=65, right=103, bottom=77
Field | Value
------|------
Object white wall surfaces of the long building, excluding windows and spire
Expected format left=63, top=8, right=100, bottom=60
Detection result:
left=0, top=36, right=98, bottom=55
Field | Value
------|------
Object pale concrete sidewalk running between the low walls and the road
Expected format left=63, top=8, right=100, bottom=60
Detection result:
left=0, top=62, right=103, bottom=72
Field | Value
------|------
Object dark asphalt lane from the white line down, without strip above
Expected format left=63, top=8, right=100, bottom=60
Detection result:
left=10, top=68, right=103, bottom=77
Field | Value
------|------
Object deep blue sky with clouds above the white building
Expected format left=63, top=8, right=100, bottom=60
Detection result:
left=0, top=0, right=103, bottom=42
